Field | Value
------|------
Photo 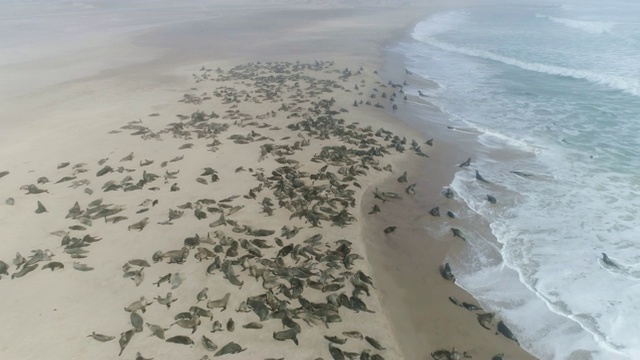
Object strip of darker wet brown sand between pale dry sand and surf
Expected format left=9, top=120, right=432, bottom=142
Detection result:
left=362, top=50, right=535, bottom=359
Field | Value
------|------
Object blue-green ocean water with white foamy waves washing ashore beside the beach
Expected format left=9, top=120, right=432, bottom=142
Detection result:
left=392, top=0, right=640, bottom=359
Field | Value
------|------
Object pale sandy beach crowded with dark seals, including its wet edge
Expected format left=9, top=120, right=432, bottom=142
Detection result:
left=0, top=1, right=533, bottom=360
